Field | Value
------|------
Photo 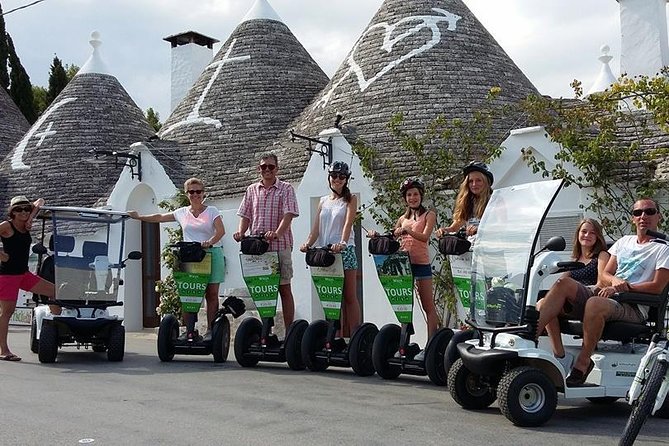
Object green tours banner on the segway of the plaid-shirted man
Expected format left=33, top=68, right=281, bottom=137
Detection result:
left=239, top=252, right=281, bottom=318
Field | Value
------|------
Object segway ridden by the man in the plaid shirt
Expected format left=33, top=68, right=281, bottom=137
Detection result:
left=235, top=236, right=309, bottom=370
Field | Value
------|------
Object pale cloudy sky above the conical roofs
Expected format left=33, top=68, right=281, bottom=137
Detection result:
left=0, top=0, right=664, bottom=121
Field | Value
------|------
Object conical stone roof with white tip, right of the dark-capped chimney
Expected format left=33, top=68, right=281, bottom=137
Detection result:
left=160, top=0, right=328, bottom=198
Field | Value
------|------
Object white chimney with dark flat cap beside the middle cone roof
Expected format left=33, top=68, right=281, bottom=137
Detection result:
left=163, top=31, right=218, bottom=113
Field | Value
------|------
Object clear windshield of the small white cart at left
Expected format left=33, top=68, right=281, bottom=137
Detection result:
left=44, top=207, right=128, bottom=302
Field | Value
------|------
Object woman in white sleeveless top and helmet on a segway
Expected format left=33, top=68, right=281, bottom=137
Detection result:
left=300, top=161, right=360, bottom=336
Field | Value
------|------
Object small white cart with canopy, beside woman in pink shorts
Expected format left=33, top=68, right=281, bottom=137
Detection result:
left=30, top=207, right=142, bottom=363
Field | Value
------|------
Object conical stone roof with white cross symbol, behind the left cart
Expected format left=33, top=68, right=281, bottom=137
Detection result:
left=0, top=73, right=154, bottom=207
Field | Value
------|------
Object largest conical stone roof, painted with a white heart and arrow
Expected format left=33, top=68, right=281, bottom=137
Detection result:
left=290, top=0, right=537, bottom=183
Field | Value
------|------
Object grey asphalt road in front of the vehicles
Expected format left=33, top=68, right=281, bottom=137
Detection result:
left=0, top=327, right=669, bottom=446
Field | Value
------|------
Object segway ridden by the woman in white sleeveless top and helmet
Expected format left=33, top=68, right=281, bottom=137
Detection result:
left=302, top=248, right=379, bottom=376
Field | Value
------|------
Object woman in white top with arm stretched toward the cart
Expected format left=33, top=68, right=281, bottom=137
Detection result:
left=128, top=178, right=225, bottom=340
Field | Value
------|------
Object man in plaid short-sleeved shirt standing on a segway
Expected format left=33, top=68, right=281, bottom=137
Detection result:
left=233, top=153, right=300, bottom=329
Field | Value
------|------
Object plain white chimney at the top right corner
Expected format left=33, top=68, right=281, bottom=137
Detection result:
left=618, top=0, right=669, bottom=77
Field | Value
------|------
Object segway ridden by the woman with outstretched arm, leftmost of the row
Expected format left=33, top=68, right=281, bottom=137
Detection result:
left=158, top=242, right=245, bottom=363
